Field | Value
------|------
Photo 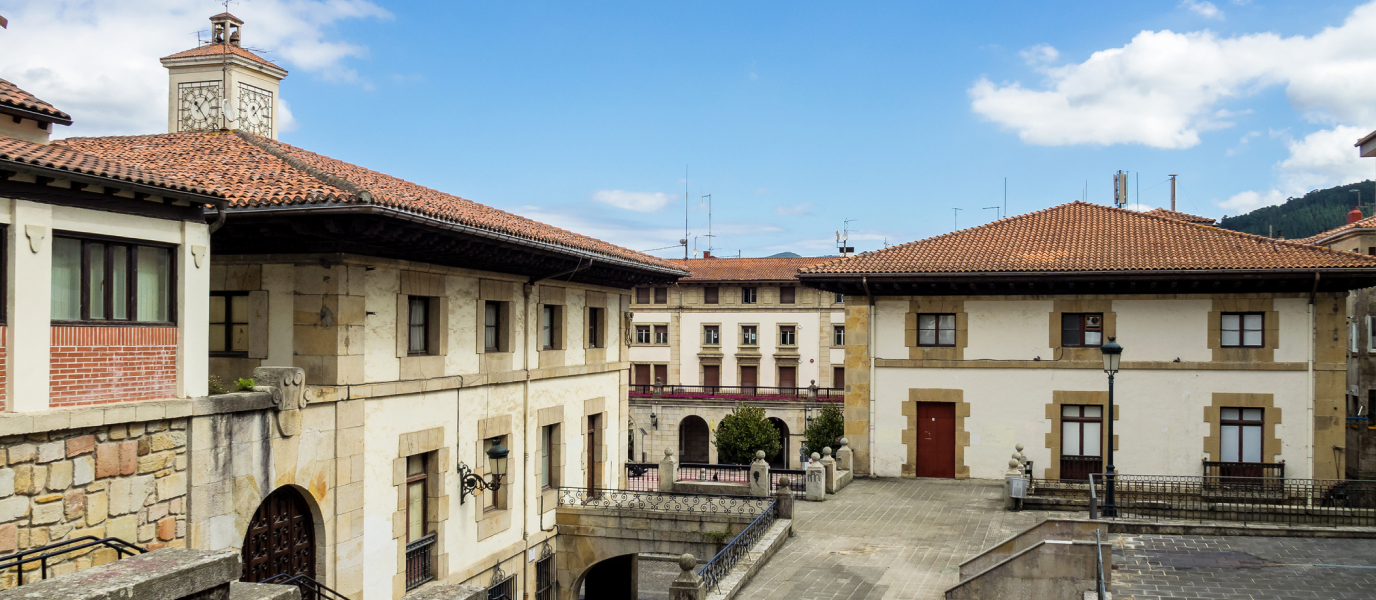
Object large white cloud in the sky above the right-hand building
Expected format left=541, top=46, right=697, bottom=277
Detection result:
left=969, top=3, right=1376, bottom=149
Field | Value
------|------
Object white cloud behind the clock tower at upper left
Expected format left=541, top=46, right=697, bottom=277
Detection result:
left=0, top=0, right=391, bottom=136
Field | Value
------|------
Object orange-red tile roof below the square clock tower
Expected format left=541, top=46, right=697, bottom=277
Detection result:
left=55, top=131, right=678, bottom=271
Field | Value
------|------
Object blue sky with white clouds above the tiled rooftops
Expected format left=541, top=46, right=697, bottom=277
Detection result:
left=0, top=0, right=1376, bottom=256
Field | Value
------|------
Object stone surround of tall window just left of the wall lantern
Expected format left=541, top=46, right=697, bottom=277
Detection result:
left=392, top=427, right=449, bottom=599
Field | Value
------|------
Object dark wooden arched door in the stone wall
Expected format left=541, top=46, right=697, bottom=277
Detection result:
left=242, top=486, right=315, bottom=582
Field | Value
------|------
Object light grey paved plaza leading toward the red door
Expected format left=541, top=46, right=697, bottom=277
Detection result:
left=738, top=479, right=1046, bottom=600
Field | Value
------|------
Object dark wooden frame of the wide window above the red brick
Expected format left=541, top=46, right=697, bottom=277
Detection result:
left=48, top=231, right=178, bottom=328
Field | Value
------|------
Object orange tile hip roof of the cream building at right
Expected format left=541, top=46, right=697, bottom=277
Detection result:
left=804, top=202, right=1376, bottom=275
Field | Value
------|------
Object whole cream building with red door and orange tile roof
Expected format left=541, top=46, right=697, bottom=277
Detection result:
left=799, top=202, right=1376, bottom=479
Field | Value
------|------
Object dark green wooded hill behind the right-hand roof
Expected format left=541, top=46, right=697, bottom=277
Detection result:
left=1218, top=179, right=1376, bottom=239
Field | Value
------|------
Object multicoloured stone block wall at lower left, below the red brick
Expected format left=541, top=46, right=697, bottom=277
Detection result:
left=0, top=418, right=187, bottom=589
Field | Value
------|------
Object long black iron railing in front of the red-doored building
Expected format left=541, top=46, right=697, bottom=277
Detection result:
left=1088, top=473, right=1376, bottom=526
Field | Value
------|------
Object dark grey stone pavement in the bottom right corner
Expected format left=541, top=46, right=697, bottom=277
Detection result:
left=1113, top=535, right=1376, bottom=600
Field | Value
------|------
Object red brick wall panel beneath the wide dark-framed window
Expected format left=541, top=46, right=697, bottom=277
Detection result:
left=48, top=326, right=176, bottom=407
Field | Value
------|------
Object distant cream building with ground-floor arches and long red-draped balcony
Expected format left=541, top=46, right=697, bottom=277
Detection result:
left=627, top=256, right=845, bottom=468
